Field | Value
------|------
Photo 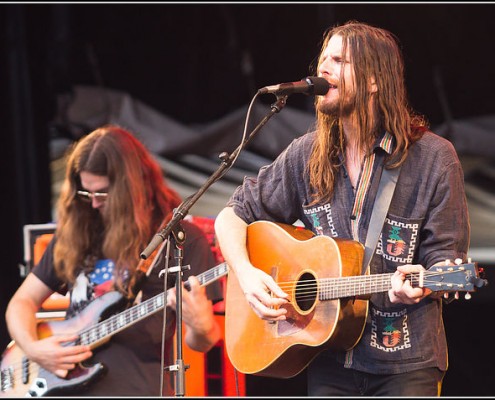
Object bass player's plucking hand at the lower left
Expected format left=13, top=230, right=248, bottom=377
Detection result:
left=26, top=335, right=93, bottom=378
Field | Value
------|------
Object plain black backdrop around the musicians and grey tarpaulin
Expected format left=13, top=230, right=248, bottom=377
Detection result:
left=0, top=3, right=495, bottom=396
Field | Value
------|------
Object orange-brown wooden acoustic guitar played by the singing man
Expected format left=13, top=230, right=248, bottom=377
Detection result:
left=225, top=221, right=486, bottom=378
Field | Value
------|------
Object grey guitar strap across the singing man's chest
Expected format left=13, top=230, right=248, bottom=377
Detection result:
left=362, top=166, right=400, bottom=275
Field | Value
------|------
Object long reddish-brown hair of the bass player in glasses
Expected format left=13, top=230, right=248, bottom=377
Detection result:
left=54, top=125, right=180, bottom=294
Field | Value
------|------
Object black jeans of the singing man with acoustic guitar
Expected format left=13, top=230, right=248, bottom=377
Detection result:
left=307, top=357, right=445, bottom=397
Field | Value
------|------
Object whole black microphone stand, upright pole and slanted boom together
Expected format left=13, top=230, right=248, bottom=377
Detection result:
left=140, top=92, right=288, bottom=396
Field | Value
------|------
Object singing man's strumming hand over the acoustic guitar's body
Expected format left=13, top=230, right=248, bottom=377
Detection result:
left=236, top=264, right=289, bottom=321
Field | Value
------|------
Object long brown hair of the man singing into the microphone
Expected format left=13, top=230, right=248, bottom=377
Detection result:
left=308, top=21, right=428, bottom=203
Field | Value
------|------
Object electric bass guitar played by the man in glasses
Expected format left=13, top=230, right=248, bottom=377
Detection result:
left=0, top=263, right=228, bottom=397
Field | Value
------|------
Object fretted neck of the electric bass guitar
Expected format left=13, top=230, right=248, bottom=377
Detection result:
left=79, top=263, right=228, bottom=347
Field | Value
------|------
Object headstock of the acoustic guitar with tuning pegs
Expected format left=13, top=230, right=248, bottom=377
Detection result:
left=423, top=259, right=488, bottom=299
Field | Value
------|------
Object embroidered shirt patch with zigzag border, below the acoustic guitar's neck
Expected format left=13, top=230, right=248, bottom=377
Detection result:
left=370, top=308, right=411, bottom=353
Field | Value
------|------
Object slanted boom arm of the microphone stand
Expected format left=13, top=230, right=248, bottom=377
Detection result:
left=140, top=95, right=288, bottom=260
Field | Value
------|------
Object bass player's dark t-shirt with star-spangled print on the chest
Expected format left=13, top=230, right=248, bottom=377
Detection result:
left=32, top=221, right=222, bottom=396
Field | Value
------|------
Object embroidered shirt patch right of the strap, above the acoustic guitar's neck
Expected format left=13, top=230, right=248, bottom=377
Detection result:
left=376, top=218, right=419, bottom=264
